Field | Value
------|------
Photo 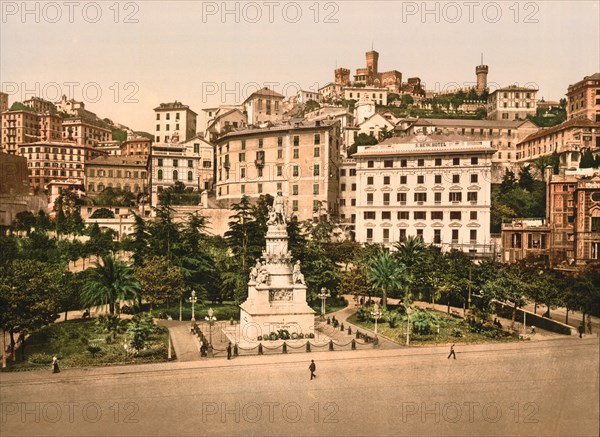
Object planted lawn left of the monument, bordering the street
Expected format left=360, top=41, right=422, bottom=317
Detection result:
left=6, top=319, right=168, bottom=371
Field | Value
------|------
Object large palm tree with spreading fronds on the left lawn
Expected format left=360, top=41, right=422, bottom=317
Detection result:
left=81, top=255, right=140, bottom=314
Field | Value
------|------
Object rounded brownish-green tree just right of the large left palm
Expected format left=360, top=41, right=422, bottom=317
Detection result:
left=135, top=256, right=183, bottom=305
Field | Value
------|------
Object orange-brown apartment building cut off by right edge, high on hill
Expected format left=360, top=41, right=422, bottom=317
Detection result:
left=567, top=73, right=600, bottom=123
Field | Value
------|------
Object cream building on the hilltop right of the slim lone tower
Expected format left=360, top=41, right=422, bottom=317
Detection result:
left=487, top=85, right=538, bottom=120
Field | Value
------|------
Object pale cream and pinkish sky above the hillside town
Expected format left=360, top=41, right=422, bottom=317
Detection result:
left=0, top=0, right=600, bottom=132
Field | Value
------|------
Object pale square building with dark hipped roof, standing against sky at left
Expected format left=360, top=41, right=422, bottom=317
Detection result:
left=154, top=100, right=198, bottom=143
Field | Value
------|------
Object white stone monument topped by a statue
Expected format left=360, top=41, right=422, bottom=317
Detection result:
left=239, top=193, right=315, bottom=342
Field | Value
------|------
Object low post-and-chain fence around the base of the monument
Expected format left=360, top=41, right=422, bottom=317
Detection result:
left=192, top=324, right=379, bottom=358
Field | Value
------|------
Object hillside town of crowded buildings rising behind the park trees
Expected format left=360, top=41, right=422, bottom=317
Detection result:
left=0, top=50, right=600, bottom=269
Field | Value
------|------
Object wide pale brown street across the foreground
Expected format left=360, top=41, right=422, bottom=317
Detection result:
left=0, top=337, right=599, bottom=437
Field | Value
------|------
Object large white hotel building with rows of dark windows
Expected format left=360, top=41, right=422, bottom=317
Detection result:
left=353, top=135, right=495, bottom=257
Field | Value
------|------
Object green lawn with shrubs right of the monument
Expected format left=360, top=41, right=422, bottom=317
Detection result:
left=348, top=310, right=518, bottom=346
